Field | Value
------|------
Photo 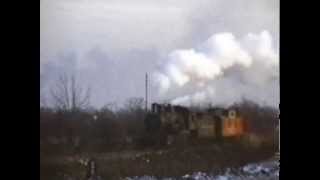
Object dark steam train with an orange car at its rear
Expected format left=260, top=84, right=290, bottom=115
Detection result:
left=145, top=103, right=248, bottom=143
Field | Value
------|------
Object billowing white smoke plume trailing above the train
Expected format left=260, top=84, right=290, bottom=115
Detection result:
left=153, top=31, right=280, bottom=106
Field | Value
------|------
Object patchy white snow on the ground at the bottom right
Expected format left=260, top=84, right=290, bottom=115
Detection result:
left=125, top=161, right=279, bottom=180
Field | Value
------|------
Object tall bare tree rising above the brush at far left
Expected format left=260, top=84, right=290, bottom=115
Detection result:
left=51, top=74, right=90, bottom=111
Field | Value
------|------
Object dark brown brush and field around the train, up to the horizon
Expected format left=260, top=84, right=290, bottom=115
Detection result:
left=40, top=100, right=278, bottom=180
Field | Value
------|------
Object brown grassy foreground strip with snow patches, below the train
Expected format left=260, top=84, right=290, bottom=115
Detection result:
left=40, top=143, right=278, bottom=180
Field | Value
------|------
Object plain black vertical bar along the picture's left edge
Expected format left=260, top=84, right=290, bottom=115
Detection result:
left=0, top=1, right=40, bottom=179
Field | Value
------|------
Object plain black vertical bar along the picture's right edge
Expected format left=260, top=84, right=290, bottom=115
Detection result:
left=280, top=1, right=320, bottom=179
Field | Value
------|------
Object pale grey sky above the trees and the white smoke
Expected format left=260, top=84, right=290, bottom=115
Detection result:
left=40, top=0, right=279, bottom=107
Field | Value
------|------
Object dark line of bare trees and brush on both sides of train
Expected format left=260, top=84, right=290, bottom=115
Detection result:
left=40, top=75, right=278, bottom=152
